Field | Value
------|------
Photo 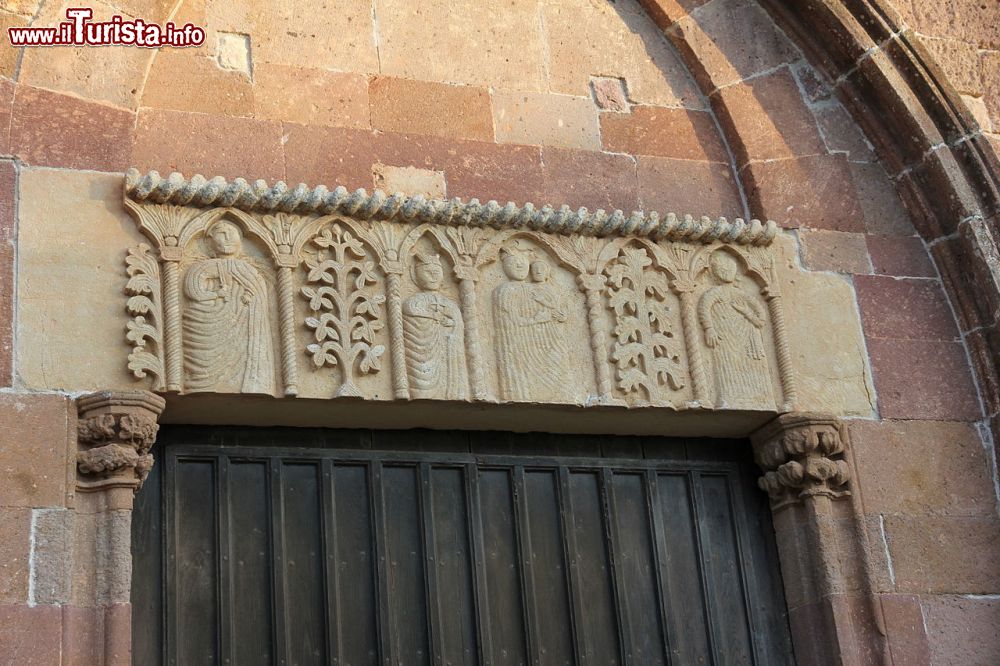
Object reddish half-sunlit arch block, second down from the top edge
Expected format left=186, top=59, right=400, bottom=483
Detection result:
left=711, top=67, right=826, bottom=166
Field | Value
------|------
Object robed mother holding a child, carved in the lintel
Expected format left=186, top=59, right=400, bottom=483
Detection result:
left=493, top=249, right=571, bottom=400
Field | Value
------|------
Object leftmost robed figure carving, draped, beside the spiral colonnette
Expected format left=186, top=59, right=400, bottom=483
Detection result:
left=184, top=221, right=274, bottom=393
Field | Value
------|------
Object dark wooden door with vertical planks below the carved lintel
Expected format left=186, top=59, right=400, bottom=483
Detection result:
left=133, top=427, right=791, bottom=666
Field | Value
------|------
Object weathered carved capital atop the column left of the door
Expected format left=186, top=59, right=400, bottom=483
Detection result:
left=76, top=391, right=165, bottom=492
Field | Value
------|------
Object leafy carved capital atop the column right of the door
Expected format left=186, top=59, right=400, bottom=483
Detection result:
left=751, top=414, right=850, bottom=509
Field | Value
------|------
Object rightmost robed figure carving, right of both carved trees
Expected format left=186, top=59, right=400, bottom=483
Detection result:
left=698, top=250, right=773, bottom=407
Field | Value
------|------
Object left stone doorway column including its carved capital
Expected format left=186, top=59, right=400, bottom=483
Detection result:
left=69, top=391, right=164, bottom=666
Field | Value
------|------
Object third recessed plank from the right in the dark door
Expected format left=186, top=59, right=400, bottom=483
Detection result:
left=611, top=472, right=666, bottom=664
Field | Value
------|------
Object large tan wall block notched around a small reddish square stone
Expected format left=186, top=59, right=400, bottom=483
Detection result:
left=544, top=0, right=704, bottom=108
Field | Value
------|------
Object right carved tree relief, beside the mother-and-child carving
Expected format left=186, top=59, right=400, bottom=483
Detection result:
left=605, top=246, right=685, bottom=402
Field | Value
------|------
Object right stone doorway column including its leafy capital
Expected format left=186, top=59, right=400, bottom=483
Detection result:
left=751, top=413, right=889, bottom=665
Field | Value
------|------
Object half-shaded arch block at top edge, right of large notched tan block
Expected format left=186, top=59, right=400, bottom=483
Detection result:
left=667, top=0, right=800, bottom=91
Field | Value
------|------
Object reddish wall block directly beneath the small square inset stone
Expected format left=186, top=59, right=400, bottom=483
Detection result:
left=601, top=106, right=729, bottom=162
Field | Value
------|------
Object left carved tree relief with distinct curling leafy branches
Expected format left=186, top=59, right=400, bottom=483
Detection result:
left=302, top=224, right=385, bottom=397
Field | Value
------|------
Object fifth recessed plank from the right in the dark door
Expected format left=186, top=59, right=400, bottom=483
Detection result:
left=524, top=470, right=574, bottom=666
